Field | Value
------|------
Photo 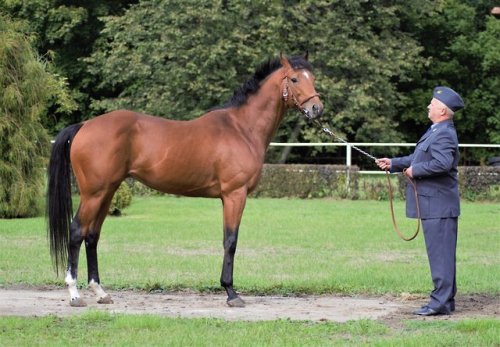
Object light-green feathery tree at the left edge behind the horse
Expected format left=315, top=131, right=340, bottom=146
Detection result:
left=0, top=16, right=72, bottom=218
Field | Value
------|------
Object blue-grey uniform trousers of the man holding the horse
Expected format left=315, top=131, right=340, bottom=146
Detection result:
left=422, top=218, right=458, bottom=313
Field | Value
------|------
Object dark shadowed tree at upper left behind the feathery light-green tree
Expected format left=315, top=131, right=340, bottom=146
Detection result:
left=0, top=0, right=138, bottom=136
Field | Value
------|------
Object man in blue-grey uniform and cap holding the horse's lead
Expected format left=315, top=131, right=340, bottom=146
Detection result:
left=375, top=87, right=464, bottom=316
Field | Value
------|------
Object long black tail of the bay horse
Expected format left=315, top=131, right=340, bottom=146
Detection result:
left=46, top=123, right=83, bottom=273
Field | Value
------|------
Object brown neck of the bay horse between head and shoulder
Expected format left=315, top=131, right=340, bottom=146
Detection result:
left=238, top=77, right=286, bottom=151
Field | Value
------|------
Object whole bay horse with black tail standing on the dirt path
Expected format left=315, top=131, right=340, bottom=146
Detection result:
left=47, top=53, right=323, bottom=307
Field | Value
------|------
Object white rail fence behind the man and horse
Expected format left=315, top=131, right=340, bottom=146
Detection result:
left=270, top=142, right=500, bottom=174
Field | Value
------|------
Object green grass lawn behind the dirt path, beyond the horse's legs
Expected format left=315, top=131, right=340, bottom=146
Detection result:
left=0, top=196, right=500, bottom=294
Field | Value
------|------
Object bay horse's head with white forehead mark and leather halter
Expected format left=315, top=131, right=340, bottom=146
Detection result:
left=280, top=53, right=323, bottom=119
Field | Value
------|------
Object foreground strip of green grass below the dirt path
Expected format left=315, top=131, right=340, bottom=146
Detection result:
left=0, top=311, right=500, bottom=346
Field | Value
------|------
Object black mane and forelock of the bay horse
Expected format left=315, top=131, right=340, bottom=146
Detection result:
left=216, top=56, right=312, bottom=109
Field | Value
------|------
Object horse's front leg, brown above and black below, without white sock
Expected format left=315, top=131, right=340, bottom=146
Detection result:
left=220, top=189, right=247, bottom=307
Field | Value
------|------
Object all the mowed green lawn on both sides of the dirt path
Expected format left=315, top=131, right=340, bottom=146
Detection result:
left=0, top=196, right=500, bottom=346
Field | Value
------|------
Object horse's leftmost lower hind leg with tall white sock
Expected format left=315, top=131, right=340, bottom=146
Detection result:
left=64, top=212, right=87, bottom=307
